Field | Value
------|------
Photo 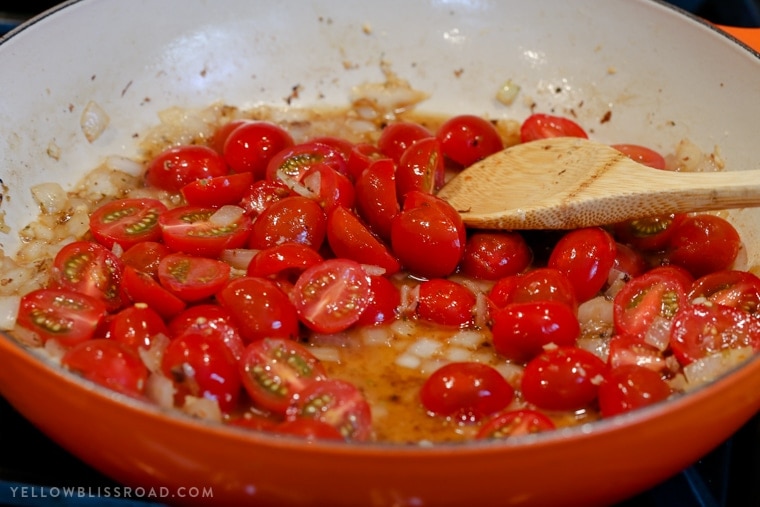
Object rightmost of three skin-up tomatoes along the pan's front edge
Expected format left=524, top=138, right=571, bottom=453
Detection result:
left=599, top=364, right=672, bottom=417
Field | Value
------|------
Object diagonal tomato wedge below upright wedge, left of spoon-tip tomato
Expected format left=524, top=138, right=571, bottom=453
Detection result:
left=327, top=206, right=401, bottom=275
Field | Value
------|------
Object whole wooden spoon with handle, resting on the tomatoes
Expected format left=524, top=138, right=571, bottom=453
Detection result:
left=438, top=137, right=760, bottom=229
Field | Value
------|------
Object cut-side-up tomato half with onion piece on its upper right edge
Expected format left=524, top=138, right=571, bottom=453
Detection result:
left=158, top=206, right=251, bottom=258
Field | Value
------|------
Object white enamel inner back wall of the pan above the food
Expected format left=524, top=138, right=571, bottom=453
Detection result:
left=0, top=0, right=760, bottom=263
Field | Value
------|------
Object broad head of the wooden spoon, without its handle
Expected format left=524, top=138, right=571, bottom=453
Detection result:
left=438, top=137, right=654, bottom=229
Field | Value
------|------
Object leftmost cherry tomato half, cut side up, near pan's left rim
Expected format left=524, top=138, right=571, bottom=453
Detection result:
left=17, top=289, right=106, bottom=347
